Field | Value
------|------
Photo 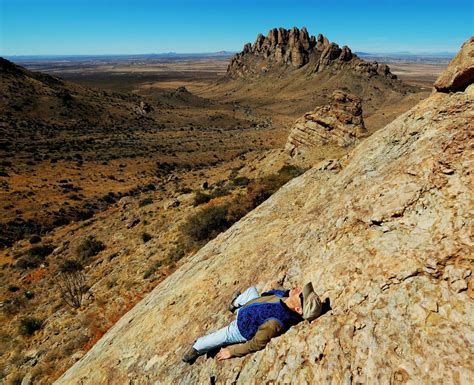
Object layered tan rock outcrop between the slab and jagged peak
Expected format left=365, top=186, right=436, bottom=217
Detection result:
left=285, top=90, right=367, bottom=157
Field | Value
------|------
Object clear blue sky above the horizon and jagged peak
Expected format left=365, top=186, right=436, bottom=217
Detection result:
left=0, top=0, right=474, bottom=56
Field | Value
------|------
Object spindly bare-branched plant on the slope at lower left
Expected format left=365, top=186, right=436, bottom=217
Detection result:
left=58, top=260, right=86, bottom=309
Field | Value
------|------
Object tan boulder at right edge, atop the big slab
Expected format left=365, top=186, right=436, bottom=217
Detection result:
left=434, top=36, right=474, bottom=92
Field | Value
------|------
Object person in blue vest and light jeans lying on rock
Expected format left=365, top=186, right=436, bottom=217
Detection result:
left=182, top=282, right=322, bottom=365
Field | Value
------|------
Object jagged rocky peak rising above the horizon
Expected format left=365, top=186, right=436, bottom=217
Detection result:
left=227, top=27, right=396, bottom=79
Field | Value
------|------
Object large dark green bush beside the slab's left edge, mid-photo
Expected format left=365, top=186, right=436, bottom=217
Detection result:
left=181, top=203, right=229, bottom=242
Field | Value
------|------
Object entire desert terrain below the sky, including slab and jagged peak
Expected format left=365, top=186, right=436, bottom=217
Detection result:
left=0, top=21, right=474, bottom=385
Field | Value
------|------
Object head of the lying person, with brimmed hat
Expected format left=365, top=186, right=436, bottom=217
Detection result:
left=285, top=282, right=322, bottom=321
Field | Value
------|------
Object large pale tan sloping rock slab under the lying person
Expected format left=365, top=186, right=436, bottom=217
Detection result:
left=57, top=37, right=474, bottom=384
